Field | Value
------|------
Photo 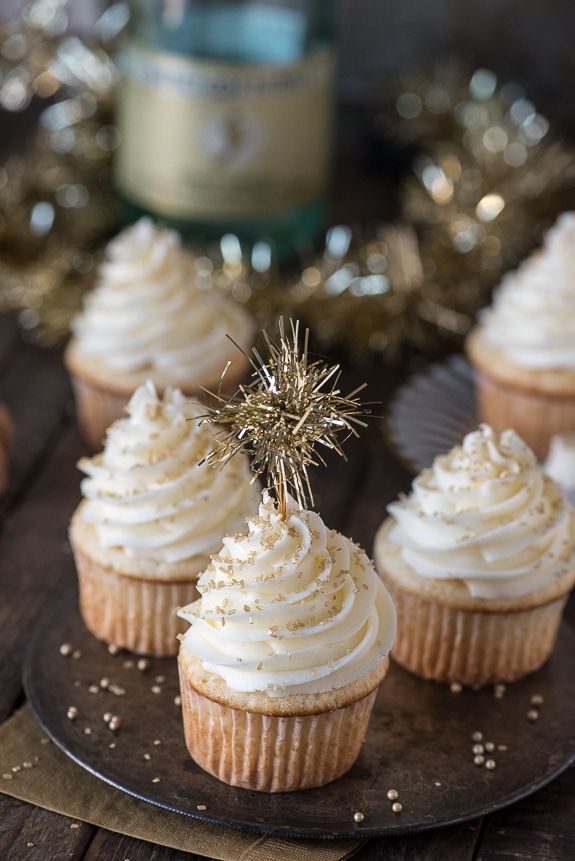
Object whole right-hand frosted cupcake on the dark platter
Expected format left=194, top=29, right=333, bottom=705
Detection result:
left=375, top=425, right=575, bottom=686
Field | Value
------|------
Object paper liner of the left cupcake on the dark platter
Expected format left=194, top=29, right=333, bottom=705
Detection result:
left=74, top=547, right=198, bottom=657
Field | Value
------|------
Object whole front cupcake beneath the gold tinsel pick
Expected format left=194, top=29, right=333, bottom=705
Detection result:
left=178, top=495, right=395, bottom=792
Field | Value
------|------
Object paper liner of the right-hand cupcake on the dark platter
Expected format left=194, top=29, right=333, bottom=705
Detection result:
left=384, top=577, right=567, bottom=687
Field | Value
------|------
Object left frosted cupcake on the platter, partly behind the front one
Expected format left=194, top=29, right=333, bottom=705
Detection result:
left=70, top=382, right=259, bottom=655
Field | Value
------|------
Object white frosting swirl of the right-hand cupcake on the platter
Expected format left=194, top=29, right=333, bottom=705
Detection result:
left=382, top=425, right=575, bottom=599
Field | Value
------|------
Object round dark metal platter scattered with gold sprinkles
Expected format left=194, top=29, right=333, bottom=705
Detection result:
left=24, top=591, right=575, bottom=838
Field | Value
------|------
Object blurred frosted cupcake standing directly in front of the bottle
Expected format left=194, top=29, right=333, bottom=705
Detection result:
left=65, top=218, right=253, bottom=450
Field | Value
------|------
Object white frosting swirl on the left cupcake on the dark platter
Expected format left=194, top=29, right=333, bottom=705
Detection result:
left=78, top=382, right=259, bottom=563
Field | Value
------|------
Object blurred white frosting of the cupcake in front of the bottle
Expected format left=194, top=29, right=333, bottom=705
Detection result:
left=72, top=218, right=253, bottom=390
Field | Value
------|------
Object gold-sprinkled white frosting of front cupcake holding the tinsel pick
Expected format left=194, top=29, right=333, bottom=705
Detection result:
left=179, top=494, right=395, bottom=697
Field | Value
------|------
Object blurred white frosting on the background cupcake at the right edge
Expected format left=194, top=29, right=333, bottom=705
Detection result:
left=480, top=212, right=575, bottom=370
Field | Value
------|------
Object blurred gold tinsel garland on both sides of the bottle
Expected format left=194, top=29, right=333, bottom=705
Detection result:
left=0, top=15, right=575, bottom=361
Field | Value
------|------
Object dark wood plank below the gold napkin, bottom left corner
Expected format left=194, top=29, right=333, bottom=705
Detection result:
left=0, top=795, right=93, bottom=861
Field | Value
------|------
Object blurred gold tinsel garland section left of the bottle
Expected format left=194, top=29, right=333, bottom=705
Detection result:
left=0, top=0, right=125, bottom=343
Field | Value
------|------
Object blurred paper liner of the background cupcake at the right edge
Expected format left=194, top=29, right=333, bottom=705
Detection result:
left=477, top=373, right=575, bottom=459
